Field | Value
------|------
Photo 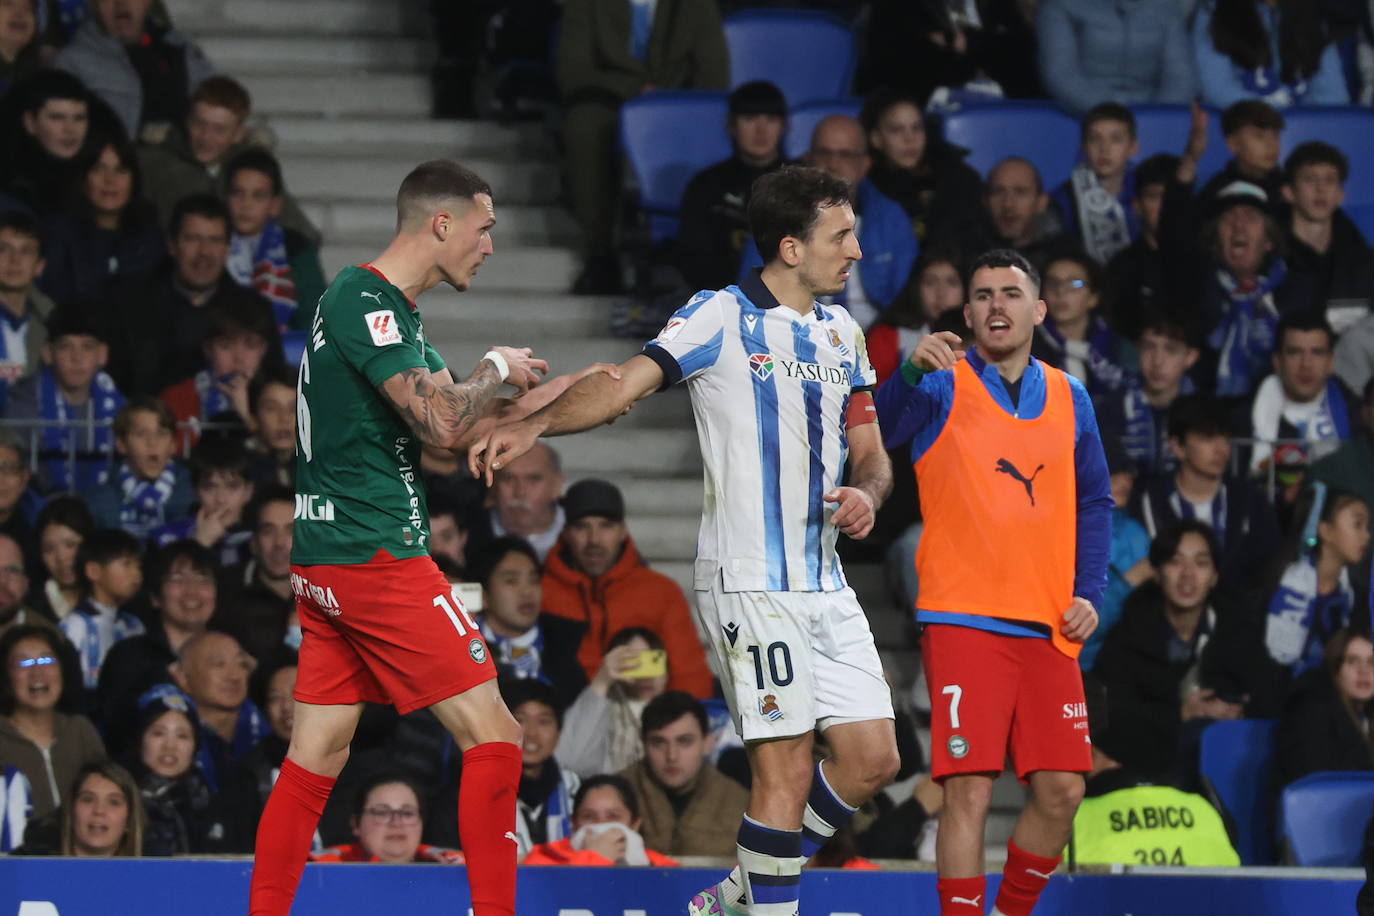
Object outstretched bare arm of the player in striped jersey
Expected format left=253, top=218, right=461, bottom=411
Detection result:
left=467, top=354, right=664, bottom=483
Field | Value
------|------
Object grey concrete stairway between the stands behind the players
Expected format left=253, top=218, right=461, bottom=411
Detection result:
left=168, top=0, right=1010, bottom=856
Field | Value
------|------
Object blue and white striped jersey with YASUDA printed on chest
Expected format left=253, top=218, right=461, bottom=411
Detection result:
left=644, top=272, right=875, bottom=592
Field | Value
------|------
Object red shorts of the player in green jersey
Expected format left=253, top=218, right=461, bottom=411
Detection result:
left=291, top=556, right=496, bottom=714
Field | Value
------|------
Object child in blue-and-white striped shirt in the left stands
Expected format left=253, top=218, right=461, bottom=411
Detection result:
left=58, top=529, right=143, bottom=691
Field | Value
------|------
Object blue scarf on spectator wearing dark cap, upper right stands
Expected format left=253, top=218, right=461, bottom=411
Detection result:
left=1206, top=258, right=1287, bottom=397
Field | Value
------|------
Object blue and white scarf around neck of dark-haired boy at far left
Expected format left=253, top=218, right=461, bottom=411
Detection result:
left=38, top=365, right=124, bottom=492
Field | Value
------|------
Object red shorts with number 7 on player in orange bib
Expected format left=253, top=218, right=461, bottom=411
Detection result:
left=921, top=623, right=1092, bottom=781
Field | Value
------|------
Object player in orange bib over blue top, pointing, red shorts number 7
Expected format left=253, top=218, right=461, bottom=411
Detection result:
left=875, top=250, right=1112, bottom=916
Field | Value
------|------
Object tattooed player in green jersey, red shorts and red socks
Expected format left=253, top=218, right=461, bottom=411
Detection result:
left=249, top=161, right=614, bottom=916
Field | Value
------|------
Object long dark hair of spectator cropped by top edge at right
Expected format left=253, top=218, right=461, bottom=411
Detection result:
left=1194, top=0, right=1326, bottom=84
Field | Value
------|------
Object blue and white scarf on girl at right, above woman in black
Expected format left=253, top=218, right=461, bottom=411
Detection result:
left=1264, top=556, right=1355, bottom=677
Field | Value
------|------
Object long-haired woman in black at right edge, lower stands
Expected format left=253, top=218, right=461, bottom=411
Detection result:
left=1274, top=629, right=1374, bottom=788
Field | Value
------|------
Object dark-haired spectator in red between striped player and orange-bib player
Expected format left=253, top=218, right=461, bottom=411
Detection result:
left=864, top=247, right=965, bottom=385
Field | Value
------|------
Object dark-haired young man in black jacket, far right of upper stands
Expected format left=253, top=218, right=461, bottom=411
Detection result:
left=1283, top=140, right=1374, bottom=338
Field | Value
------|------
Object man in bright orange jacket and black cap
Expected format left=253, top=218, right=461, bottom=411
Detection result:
left=544, top=479, right=712, bottom=698
